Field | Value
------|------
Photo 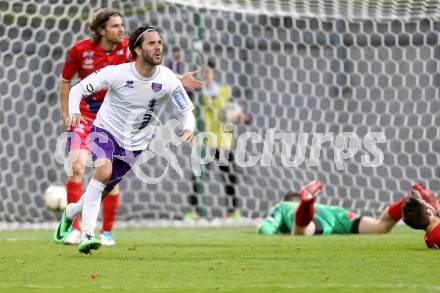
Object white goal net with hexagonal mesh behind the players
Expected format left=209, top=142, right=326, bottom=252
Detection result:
left=0, top=0, right=440, bottom=223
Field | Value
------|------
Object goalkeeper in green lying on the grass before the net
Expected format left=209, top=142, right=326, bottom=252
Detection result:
left=257, top=180, right=422, bottom=235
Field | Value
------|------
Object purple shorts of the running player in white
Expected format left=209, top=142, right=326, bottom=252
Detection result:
left=88, top=125, right=142, bottom=192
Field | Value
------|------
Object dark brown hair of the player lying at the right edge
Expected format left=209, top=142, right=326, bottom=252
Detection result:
left=402, top=194, right=429, bottom=230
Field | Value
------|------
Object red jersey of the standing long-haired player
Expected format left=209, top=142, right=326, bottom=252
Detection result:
left=61, top=37, right=130, bottom=120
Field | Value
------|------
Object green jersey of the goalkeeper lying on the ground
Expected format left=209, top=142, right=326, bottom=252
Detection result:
left=257, top=201, right=354, bottom=235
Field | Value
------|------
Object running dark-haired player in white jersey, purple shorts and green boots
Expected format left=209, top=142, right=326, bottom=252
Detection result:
left=54, top=26, right=195, bottom=254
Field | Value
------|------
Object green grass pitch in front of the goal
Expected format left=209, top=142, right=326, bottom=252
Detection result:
left=0, top=227, right=440, bottom=292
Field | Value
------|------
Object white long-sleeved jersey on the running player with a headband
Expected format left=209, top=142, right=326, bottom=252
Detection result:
left=72, top=62, right=194, bottom=150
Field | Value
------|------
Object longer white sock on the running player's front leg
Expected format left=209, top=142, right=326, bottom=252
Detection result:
left=81, top=179, right=105, bottom=235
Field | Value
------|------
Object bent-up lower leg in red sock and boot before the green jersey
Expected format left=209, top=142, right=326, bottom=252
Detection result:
left=292, top=180, right=322, bottom=235
